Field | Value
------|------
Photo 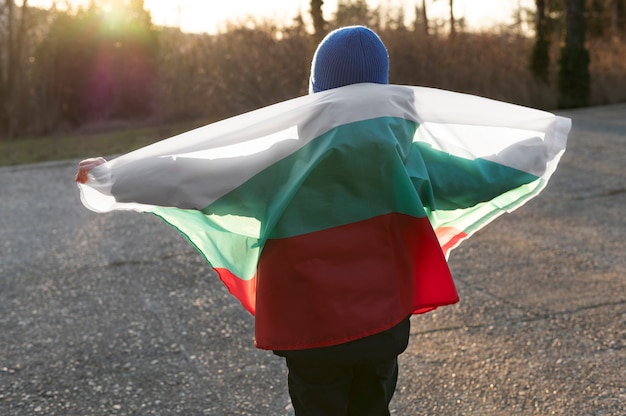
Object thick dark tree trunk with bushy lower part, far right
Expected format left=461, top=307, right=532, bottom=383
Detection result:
left=559, top=0, right=591, bottom=108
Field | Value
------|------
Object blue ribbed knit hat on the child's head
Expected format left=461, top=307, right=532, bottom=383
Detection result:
left=309, top=26, right=389, bottom=93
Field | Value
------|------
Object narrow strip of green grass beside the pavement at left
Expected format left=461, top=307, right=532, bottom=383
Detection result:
left=0, top=121, right=205, bottom=166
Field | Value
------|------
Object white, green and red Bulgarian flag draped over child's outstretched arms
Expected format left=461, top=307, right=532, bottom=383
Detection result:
left=79, top=84, right=571, bottom=349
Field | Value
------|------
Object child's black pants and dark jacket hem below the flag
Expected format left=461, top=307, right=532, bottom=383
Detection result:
left=275, top=318, right=410, bottom=416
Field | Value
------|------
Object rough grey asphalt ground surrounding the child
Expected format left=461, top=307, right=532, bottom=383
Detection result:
left=0, top=105, right=626, bottom=416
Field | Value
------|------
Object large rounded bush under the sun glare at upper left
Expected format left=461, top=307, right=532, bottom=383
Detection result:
left=37, top=0, right=158, bottom=129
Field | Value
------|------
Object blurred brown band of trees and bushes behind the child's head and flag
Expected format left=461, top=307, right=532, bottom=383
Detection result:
left=0, top=0, right=626, bottom=140
